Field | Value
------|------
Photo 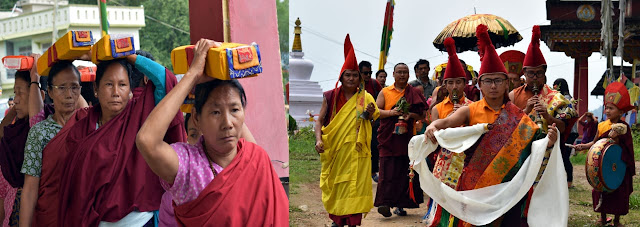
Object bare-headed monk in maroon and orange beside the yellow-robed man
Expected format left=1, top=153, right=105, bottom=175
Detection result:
left=374, top=63, right=427, bottom=217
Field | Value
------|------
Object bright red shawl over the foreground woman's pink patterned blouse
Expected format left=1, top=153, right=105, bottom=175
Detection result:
left=173, top=139, right=289, bottom=226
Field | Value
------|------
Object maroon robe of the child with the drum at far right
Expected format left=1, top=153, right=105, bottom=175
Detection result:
left=591, top=120, right=636, bottom=215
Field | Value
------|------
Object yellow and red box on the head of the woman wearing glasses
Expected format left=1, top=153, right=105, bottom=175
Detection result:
left=37, top=31, right=94, bottom=76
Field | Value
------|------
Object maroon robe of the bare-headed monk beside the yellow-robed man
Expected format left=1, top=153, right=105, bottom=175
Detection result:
left=374, top=84, right=427, bottom=208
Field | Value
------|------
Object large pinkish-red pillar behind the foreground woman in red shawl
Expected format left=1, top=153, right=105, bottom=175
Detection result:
left=189, top=0, right=289, bottom=177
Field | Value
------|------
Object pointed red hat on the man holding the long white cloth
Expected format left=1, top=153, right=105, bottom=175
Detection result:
left=476, top=24, right=507, bottom=80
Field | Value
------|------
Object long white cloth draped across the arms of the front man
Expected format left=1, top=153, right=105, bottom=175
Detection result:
left=409, top=124, right=569, bottom=227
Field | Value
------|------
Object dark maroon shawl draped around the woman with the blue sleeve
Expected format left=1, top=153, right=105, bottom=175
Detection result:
left=36, top=70, right=186, bottom=226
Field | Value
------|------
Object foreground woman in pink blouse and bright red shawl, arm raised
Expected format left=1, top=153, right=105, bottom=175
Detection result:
left=136, top=40, right=289, bottom=226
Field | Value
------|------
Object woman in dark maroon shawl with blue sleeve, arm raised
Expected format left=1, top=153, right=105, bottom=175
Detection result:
left=34, top=49, right=186, bottom=226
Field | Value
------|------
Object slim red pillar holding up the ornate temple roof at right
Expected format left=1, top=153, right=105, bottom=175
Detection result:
left=573, top=56, right=589, bottom=135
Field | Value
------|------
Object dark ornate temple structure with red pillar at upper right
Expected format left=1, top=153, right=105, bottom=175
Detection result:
left=540, top=0, right=640, bottom=129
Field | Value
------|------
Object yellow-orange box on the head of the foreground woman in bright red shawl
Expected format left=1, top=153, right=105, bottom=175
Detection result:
left=171, top=43, right=262, bottom=80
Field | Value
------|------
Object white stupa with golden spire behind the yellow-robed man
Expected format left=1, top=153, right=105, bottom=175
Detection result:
left=289, top=18, right=322, bottom=128
